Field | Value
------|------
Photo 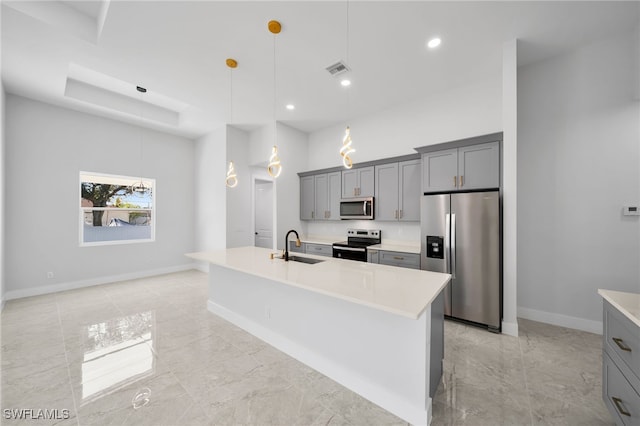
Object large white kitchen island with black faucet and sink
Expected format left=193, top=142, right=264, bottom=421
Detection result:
left=187, top=247, right=450, bottom=424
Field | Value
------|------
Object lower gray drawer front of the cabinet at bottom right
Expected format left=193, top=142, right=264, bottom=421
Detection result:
left=602, top=352, right=640, bottom=426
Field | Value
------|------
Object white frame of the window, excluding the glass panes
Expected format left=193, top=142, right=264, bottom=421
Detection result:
left=76, top=170, right=157, bottom=247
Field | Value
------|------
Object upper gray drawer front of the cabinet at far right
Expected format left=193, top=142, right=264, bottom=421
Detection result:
left=604, top=301, right=640, bottom=382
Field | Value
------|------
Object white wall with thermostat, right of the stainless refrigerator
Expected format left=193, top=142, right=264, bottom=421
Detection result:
left=517, top=28, right=640, bottom=332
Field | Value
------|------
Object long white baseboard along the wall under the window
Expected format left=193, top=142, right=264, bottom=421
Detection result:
left=2, top=263, right=200, bottom=305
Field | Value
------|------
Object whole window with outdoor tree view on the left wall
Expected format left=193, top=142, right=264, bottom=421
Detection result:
left=79, top=172, right=155, bottom=246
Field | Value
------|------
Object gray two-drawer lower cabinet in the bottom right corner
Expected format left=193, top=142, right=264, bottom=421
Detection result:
left=602, top=300, right=640, bottom=426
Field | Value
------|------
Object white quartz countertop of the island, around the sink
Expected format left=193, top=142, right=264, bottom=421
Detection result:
left=187, top=247, right=451, bottom=319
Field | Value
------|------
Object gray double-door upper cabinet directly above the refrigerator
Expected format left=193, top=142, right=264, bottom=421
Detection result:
left=422, top=142, right=500, bottom=192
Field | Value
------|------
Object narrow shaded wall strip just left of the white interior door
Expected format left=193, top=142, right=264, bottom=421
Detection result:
left=226, top=126, right=254, bottom=248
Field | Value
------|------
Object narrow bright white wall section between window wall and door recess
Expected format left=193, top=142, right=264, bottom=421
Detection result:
left=194, top=127, right=227, bottom=251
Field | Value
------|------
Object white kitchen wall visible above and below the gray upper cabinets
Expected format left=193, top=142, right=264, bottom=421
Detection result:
left=305, top=77, right=502, bottom=244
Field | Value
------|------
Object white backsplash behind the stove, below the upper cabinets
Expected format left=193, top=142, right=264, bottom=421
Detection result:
left=303, top=220, right=420, bottom=243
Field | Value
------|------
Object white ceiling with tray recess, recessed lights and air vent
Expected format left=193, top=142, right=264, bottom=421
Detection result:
left=2, top=0, right=640, bottom=138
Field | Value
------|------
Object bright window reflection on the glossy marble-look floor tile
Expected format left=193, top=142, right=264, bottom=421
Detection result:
left=82, top=311, right=155, bottom=405
